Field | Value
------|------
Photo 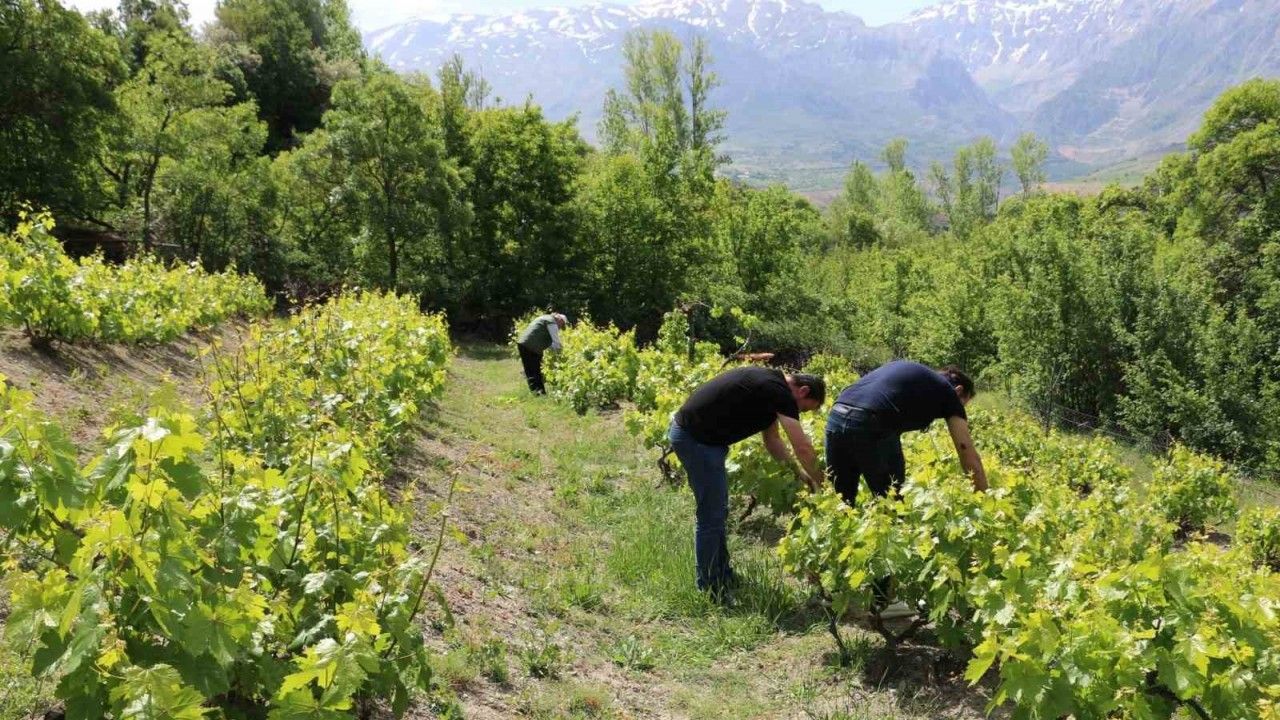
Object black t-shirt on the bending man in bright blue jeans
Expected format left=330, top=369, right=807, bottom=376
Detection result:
left=676, top=368, right=800, bottom=446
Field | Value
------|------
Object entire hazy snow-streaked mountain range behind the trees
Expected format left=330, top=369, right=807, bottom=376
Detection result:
left=366, top=0, right=1280, bottom=188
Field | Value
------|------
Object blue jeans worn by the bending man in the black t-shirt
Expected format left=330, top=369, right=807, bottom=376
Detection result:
left=667, top=420, right=733, bottom=591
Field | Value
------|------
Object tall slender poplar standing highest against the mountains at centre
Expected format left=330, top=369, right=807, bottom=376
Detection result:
left=582, top=31, right=726, bottom=334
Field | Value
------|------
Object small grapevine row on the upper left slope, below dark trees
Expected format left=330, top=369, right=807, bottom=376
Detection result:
left=0, top=213, right=270, bottom=342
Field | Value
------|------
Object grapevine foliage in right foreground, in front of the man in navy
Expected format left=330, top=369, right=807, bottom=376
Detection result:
left=780, top=414, right=1280, bottom=717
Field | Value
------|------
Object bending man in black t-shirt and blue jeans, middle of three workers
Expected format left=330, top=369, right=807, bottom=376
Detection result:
left=667, top=366, right=827, bottom=598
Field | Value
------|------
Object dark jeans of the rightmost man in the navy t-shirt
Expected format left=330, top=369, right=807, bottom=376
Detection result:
left=827, top=404, right=906, bottom=505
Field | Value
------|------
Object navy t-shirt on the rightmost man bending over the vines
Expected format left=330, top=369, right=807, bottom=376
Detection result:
left=837, top=360, right=969, bottom=433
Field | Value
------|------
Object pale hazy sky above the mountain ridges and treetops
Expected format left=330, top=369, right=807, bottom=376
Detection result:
left=69, top=0, right=937, bottom=31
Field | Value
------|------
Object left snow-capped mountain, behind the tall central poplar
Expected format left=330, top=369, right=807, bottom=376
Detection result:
left=366, top=0, right=1016, bottom=186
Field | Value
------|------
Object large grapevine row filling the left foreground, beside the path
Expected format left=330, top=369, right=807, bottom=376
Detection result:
left=0, top=289, right=449, bottom=720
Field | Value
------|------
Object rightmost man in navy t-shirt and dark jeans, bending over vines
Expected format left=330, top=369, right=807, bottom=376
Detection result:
left=827, top=360, right=987, bottom=505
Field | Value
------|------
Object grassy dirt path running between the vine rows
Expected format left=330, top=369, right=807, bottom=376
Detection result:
left=398, top=346, right=987, bottom=720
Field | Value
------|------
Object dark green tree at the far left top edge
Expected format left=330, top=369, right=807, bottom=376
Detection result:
left=0, top=0, right=125, bottom=224
